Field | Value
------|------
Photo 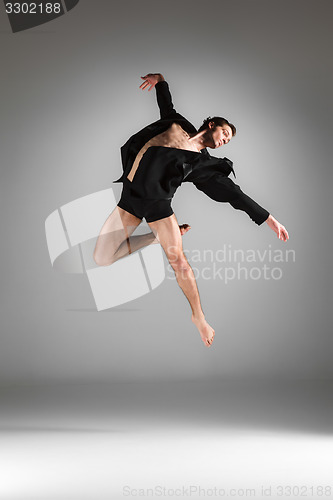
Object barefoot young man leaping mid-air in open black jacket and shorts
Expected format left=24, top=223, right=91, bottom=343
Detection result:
left=94, top=73, right=289, bottom=346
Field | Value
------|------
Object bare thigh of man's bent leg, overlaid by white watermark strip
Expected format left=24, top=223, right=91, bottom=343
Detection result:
left=94, top=205, right=141, bottom=265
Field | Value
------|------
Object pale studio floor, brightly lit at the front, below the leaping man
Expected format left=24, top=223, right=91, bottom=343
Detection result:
left=0, top=380, right=333, bottom=500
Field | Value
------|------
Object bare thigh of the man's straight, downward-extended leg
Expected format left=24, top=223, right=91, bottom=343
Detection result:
left=148, top=214, right=184, bottom=265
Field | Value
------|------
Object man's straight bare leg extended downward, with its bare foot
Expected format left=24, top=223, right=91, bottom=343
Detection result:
left=148, top=214, right=215, bottom=346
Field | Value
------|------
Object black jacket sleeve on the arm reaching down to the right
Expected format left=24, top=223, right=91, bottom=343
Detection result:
left=193, top=174, right=269, bottom=226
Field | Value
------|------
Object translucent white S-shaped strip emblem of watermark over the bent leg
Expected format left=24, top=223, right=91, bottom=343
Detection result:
left=45, top=188, right=165, bottom=311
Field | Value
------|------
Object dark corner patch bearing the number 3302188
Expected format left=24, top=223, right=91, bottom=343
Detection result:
left=4, top=0, right=79, bottom=33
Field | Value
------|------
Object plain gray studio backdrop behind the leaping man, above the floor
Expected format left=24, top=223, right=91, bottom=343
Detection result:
left=0, top=0, right=333, bottom=385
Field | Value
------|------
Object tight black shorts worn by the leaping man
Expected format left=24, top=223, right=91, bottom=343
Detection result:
left=117, top=179, right=174, bottom=222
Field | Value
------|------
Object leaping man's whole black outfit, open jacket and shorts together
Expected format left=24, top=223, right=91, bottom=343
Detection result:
left=114, top=81, right=269, bottom=225
